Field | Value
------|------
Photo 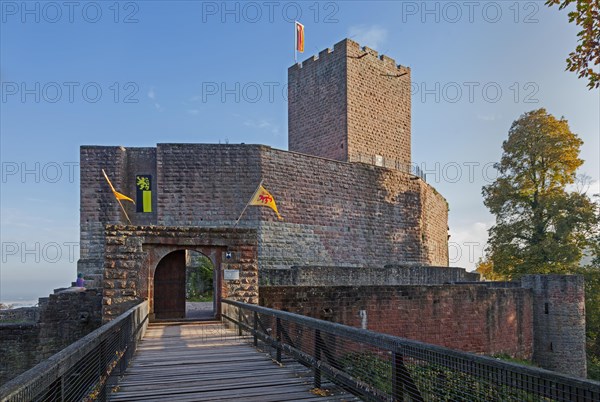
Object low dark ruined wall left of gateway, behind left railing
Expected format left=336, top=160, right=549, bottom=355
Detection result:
left=0, top=289, right=102, bottom=385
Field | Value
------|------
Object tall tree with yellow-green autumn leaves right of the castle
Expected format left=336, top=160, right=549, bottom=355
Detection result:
left=483, top=109, right=598, bottom=278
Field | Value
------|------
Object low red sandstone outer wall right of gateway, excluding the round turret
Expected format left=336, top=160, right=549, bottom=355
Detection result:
left=259, top=285, right=533, bottom=358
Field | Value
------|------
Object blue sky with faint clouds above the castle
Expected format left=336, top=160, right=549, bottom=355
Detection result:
left=0, top=0, right=600, bottom=300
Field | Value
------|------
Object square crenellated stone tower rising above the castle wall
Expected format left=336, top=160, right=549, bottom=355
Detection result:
left=288, top=39, right=411, bottom=170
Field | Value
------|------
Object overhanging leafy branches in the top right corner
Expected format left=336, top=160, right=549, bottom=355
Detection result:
left=546, top=0, right=600, bottom=89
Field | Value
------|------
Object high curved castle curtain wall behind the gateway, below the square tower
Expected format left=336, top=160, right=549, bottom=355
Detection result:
left=80, top=144, right=448, bottom=284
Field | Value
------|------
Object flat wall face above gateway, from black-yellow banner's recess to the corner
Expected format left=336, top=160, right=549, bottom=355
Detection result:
left=156, top=144, right=267, bottom=226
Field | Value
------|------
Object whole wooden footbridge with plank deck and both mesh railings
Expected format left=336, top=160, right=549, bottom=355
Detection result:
left=0, top=300, right=600, bottom=402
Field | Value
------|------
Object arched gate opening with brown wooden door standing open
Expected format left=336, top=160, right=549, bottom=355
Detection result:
left=152, top=247, right=222, bottom=320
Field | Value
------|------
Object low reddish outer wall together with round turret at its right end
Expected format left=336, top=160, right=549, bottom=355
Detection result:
left=259, top=274, right=586, bottom=378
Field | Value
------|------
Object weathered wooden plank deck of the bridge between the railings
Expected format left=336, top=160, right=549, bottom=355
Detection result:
left=108, top=323, right=356, bottom=402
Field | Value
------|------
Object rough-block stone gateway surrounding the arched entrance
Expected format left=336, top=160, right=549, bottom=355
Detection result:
left=102, top=225, right=258, bottom=321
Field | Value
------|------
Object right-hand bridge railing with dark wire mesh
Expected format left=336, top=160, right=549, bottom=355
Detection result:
left=222, top=300, right=600, bottom=402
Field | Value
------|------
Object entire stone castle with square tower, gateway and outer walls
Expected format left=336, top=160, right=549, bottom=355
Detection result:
left=0, top=39, right=586, bottom=380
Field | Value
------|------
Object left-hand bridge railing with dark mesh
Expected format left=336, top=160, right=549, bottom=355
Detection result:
left=0, top=301, right=148, bottom=402
